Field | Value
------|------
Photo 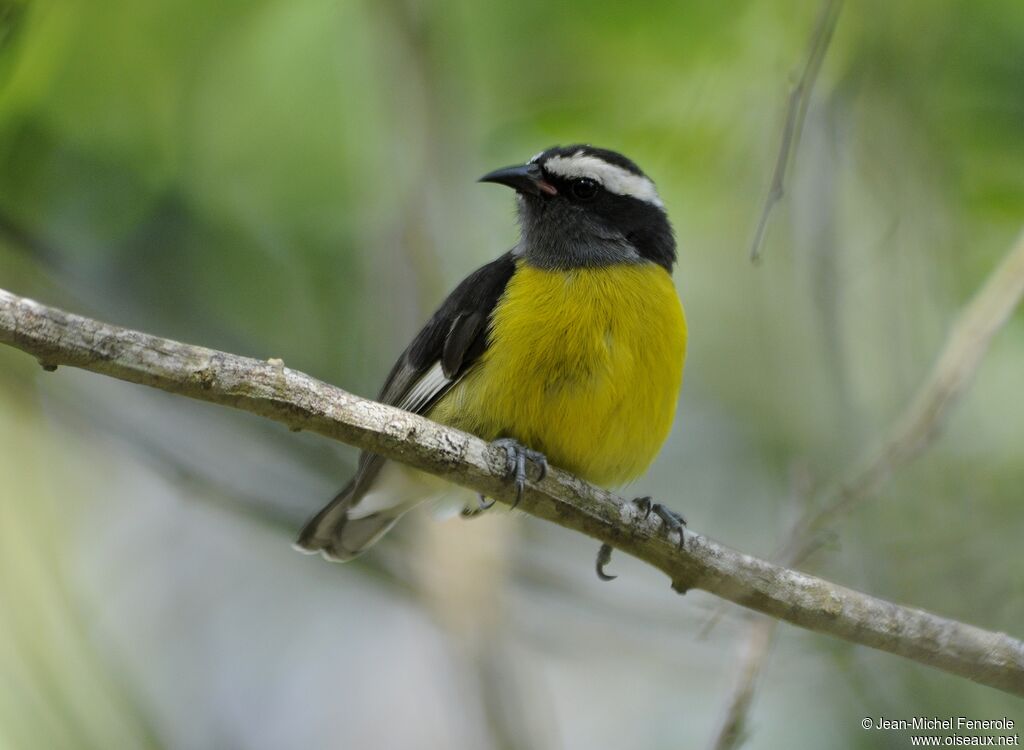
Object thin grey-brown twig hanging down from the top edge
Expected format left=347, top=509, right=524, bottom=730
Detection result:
left=751, top=0, right=843, bottom=262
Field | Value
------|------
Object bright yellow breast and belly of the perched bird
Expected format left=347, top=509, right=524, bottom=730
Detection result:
left=430, top=262, right=686, bottom=487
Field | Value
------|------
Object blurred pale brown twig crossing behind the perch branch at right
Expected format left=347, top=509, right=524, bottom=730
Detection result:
left=712, top=234, right=1024, bottom=750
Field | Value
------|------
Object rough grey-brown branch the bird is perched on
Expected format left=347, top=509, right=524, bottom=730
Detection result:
left=0, top=290, right=1024, bottom=695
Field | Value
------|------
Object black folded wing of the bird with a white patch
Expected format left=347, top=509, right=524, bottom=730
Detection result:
left=346, top=251, right=515, bottom=502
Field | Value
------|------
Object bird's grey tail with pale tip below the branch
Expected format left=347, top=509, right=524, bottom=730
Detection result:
left=294, top=482, right=407, bottom=563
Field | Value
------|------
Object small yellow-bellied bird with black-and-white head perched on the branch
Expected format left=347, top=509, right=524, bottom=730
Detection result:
left=296, top=144, right=686, bottom=580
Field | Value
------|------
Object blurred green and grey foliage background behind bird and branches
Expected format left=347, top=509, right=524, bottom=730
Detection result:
left=0, top=0, right=1024, bottom=750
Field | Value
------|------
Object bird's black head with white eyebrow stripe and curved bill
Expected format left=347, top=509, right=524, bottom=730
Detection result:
left=480, top=145, right=676, bottom=273
